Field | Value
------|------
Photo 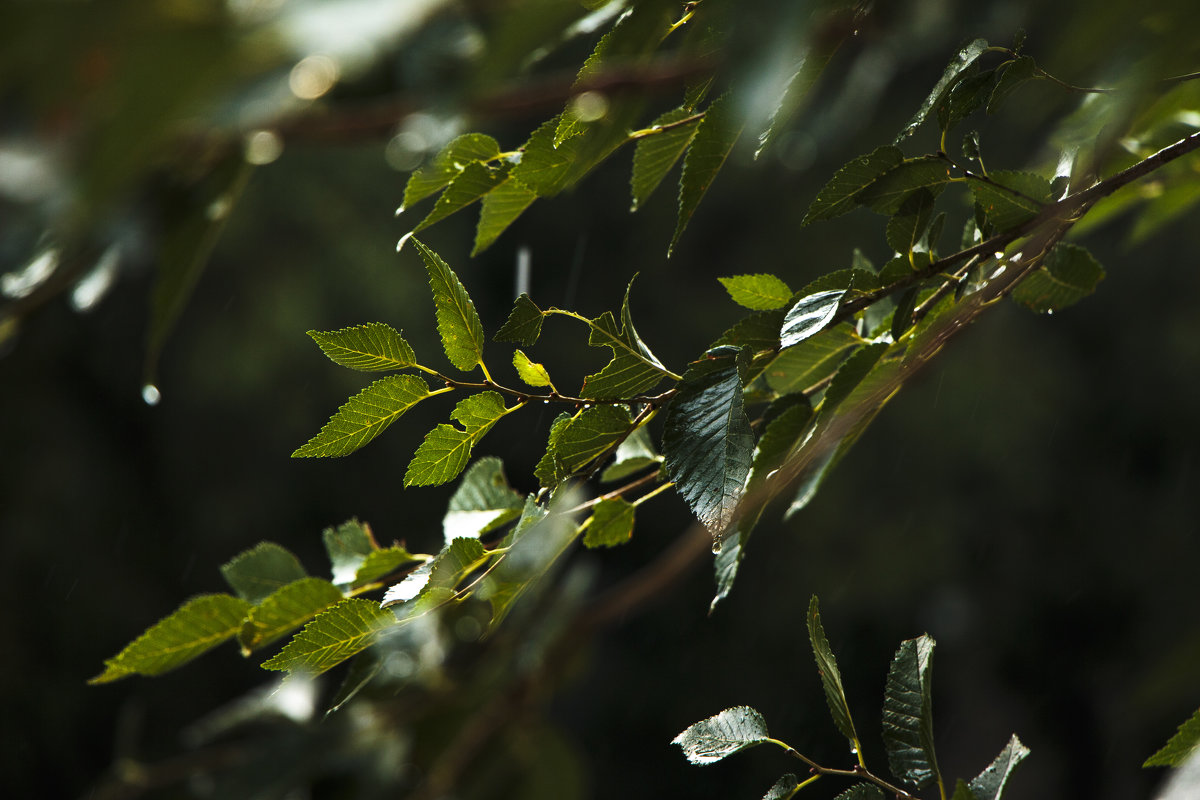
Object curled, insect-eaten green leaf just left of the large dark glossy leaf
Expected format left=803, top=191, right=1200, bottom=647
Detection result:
left=581, top=276, right=671, bottom=399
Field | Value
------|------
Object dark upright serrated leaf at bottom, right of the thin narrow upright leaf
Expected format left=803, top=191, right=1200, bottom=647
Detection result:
left=883, top=634, right=941, bottom=789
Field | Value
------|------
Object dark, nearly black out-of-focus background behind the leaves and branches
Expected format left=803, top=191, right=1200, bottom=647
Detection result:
left=0, top=0, right=1200, bottom=799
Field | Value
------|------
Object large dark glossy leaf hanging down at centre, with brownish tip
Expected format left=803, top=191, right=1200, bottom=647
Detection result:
left=662, top=356, right=754, bottom=535
